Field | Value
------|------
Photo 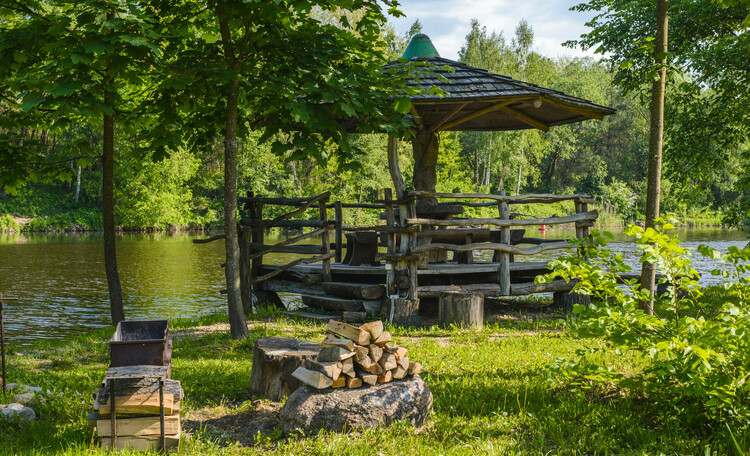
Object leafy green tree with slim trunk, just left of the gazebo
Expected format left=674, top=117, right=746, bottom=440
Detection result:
left=154, top=0, right=420, bottom=338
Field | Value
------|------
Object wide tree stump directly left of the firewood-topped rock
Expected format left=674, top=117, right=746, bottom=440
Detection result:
left=250, top=337, right=323, bottom=401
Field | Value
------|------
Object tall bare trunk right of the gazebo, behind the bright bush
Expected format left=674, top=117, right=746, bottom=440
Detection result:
left=641, top=0, right=669, bottom=315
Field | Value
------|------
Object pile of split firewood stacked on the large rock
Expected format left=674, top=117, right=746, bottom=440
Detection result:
left=292, top=320, right=422, bottom=389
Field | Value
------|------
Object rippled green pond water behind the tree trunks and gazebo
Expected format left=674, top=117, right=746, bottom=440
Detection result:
left=0, top=229, right=748, bottom=345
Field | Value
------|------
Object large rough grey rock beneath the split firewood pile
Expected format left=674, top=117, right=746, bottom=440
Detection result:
left=280, top=375, right=432, bottom=434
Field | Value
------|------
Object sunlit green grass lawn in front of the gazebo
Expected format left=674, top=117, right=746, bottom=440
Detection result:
left=0, top=310, right=746, bottom=455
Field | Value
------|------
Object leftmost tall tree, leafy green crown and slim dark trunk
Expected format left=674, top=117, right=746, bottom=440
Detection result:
left=0, top=0, right=167, bottom=324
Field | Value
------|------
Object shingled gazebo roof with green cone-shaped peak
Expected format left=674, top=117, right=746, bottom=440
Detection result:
left=385, top=35, right=615, bottom=132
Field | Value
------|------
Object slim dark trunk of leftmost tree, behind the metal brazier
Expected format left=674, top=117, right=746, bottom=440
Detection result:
left=102, top=96, right=125, bottom=326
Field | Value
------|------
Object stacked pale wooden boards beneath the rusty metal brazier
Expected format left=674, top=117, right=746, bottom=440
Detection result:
left=89, top=338, right=184, bottom=451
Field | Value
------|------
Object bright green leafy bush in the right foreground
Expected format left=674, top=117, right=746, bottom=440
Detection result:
left=545, top=219, right=750, bottom=435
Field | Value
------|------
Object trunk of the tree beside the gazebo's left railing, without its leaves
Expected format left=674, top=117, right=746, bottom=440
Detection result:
left=217, top=9, right=248, bottom=339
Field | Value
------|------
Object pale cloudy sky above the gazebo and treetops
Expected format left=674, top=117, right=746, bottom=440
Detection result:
left=390, top=0, right=594, bottom=60
